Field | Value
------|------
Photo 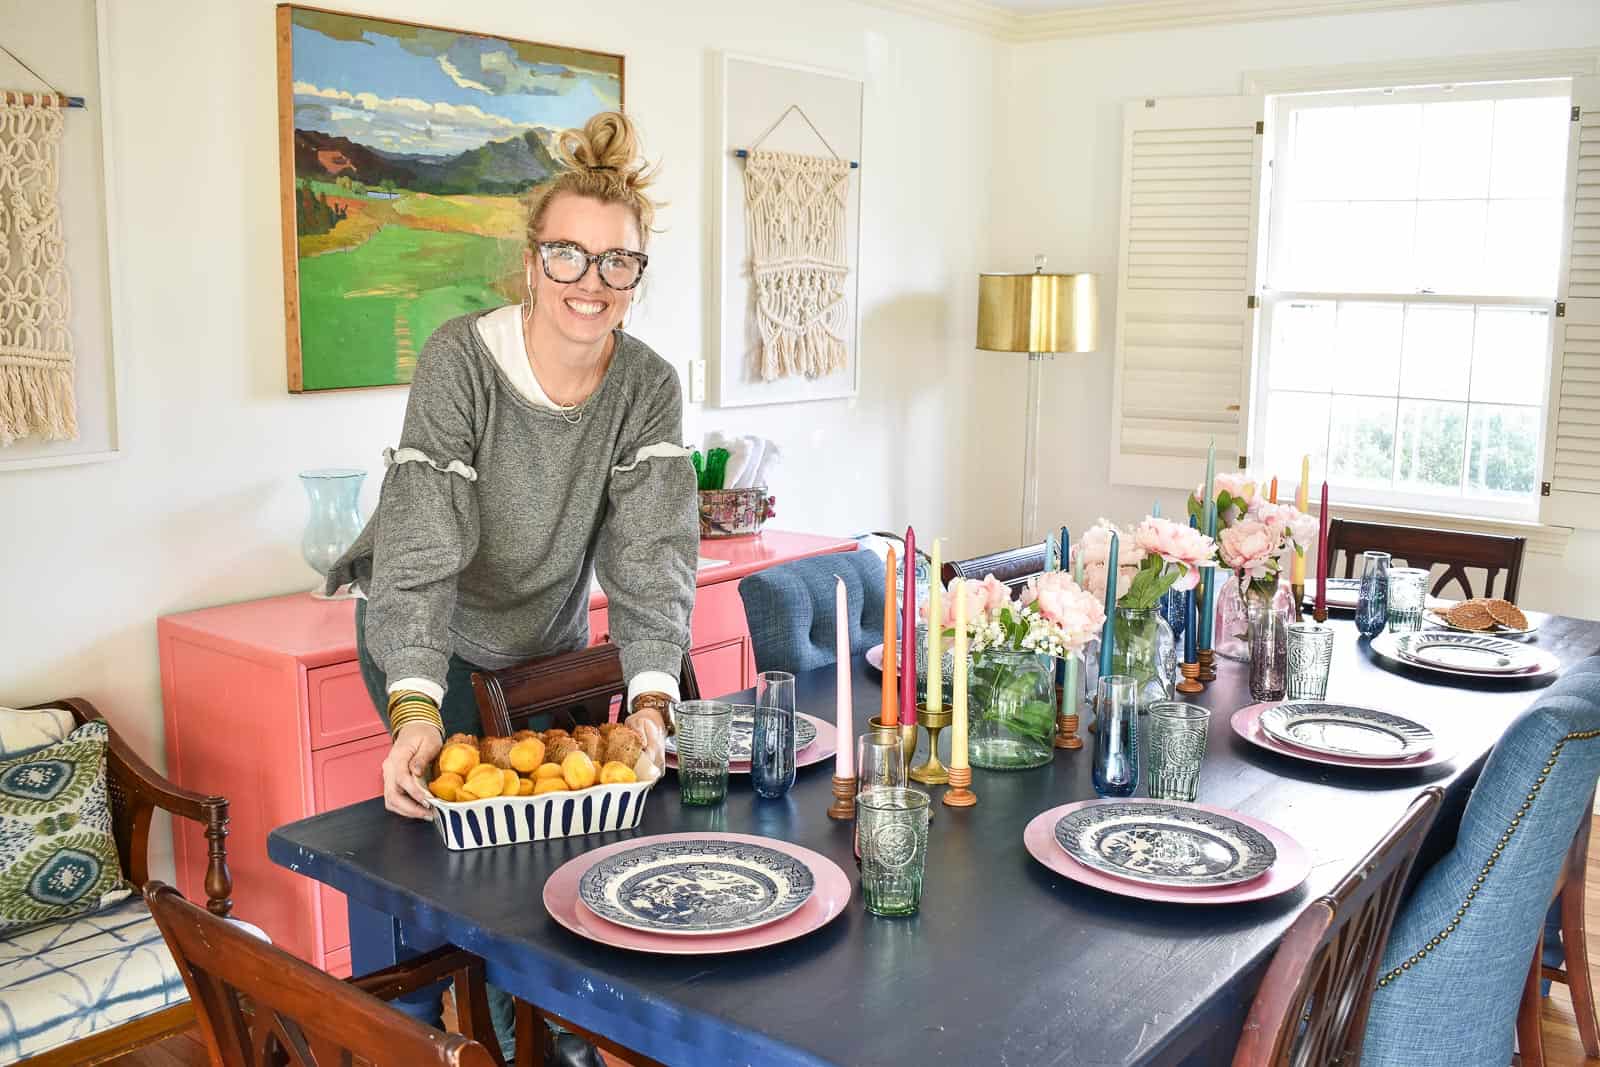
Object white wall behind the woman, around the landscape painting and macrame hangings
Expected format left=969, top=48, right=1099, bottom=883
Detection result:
left=0, top=0, right=998, bottom=869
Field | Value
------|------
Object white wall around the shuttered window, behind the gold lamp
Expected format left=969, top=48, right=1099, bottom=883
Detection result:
left=994, top=0, right=1600, bottom=617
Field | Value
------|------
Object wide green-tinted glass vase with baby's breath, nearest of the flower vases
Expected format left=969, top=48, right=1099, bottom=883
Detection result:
left=966, top=648, right=1056, bottom=771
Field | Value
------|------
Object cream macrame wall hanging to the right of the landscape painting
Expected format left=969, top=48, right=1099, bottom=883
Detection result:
left=741, top=107, right=851, bottom=381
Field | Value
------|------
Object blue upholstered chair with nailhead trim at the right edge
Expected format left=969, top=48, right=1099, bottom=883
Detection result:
left=1362, top=657, right=1600, bottom=1067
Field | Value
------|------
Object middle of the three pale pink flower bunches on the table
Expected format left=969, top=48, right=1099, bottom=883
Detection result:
left=1074, top=515, right=1216, bottom=611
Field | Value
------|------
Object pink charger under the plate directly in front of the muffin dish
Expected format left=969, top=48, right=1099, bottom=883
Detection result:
left=544, top=833, right=851, bottom=957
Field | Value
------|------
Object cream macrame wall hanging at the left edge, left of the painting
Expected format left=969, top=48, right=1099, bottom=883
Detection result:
left=0, top=93, right=78, bottom=446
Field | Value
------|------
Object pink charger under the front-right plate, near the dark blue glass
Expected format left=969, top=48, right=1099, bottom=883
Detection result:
left=1022, top=800, right=1310, bottom=904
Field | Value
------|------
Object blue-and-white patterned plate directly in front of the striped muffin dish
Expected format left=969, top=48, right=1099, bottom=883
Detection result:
left=578, top=840, right=816, bottom=936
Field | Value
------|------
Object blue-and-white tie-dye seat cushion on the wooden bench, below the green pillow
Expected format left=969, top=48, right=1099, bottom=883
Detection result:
left=0, top=897, right=189, bottom=1064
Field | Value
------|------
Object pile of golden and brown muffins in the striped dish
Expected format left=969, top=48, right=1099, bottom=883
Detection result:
left=427, top=723, right=661, bottom=803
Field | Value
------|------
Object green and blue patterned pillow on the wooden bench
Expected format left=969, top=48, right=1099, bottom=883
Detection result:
left=0, top=721, right=130, bottom=937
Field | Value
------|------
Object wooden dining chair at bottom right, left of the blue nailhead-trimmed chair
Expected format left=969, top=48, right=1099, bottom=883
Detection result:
left=1234, top=785, right=1445, bottom=1067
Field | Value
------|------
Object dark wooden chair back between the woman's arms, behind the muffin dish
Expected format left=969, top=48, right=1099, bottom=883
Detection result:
left=472, top=641, right=699, bottom=737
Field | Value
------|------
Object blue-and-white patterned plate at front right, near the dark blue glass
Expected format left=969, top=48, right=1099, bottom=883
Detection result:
left=1056, top=800, right=1278, bottom=889
